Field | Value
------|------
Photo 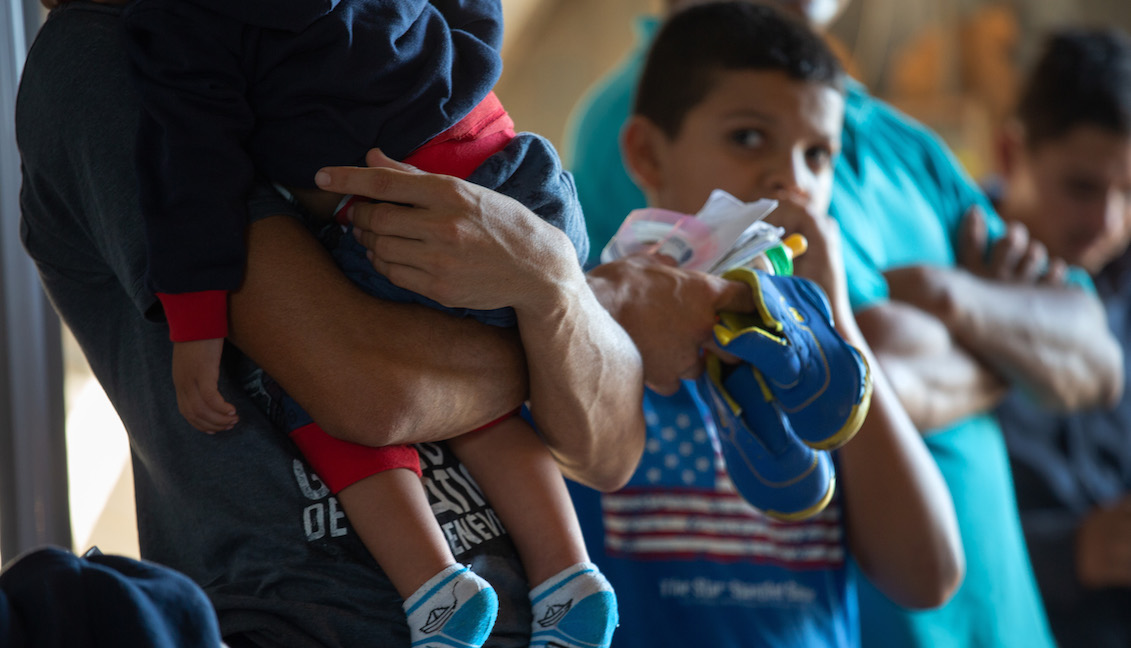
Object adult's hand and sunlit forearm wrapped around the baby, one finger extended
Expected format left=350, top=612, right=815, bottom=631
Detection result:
left=318, top=153, right=645, bottom=490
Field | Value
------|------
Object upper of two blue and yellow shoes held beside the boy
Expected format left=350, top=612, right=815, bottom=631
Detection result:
left=715, top=268, right=872, bottom=450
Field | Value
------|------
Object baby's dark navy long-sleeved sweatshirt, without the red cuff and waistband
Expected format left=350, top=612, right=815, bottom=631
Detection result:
left=123, top=0, right=502, bottom=293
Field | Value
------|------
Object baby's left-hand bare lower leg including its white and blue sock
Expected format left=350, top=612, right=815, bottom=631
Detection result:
left=338, top=468, right=499, bottom=647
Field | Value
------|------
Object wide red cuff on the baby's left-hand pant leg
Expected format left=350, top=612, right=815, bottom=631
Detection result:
left=291, top=423, right=421, bottom=494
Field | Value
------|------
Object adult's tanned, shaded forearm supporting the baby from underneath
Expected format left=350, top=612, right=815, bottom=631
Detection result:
left=230, top=216, right=527, bottom=446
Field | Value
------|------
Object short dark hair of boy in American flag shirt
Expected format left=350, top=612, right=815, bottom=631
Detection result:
left=632, top=1, right=845, bottom=137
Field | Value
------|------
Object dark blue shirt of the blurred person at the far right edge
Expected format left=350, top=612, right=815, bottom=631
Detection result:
left=998, top=248, right=1131, bottom=648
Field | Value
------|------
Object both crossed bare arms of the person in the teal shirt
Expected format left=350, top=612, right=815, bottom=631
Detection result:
left=857, top=210, right=1123, bottom=430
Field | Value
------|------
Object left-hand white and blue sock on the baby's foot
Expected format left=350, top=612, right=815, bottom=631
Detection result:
left=404, top=564, right=499, bottom=648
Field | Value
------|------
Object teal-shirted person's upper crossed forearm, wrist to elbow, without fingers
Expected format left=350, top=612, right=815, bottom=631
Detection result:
left=943, top=271, right=1123, bottom=411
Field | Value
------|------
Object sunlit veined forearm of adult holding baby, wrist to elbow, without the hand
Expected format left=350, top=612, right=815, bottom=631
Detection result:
left=516, top=260, right=645, bottom=491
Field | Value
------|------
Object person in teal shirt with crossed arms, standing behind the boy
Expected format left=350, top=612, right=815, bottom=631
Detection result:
left=567, top=2, right=1122, bottom=648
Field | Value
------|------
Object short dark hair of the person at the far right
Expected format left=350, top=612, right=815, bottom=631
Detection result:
left=1017, top=28, right=1131, bottom=148
